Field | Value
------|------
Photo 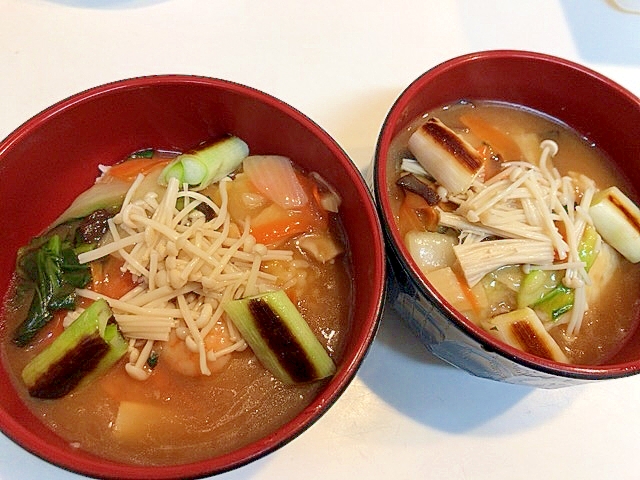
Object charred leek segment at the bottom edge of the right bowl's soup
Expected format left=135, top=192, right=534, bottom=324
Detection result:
left=487, top=308, right=569, bottom=363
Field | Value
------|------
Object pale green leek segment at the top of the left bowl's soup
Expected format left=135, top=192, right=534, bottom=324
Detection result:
left=158, top=136, right=249, bottom=190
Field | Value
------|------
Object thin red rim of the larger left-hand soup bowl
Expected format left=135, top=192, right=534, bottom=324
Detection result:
left=0, top=73, right=386, bottom=479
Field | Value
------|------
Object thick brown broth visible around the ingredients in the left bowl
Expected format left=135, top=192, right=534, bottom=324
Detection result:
left=0, top=158, right=352, bottom=465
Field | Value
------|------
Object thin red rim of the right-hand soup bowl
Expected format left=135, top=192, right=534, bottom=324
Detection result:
left=373, top=49, right=640, bottom=381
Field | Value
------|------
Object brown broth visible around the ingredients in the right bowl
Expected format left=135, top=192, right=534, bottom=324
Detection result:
left=387, top=102, right=640, bottom=364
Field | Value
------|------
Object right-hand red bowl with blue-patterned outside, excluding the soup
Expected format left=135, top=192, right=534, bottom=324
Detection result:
left=372, top=51, right=640, bottom=388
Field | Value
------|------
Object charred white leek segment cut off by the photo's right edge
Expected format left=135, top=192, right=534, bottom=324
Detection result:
left=589, top=187, right=640, bottom=263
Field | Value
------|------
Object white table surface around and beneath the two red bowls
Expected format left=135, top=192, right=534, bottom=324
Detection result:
left=0, top=0, right=640, bottom=480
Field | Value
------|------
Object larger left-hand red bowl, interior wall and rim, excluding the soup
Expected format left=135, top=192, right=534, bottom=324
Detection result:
left=0, top=75, right=385, bottom=479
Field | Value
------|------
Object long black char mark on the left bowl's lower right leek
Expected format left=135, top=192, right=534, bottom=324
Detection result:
left=247, top=298, right=316, bottom=382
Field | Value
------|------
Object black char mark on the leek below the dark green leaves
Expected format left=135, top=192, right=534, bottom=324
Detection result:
left=29, top=333, right=109, bottom=399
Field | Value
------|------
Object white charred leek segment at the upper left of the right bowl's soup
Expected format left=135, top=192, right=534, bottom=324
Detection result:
left=408, top=118, right=483, bottom=195
